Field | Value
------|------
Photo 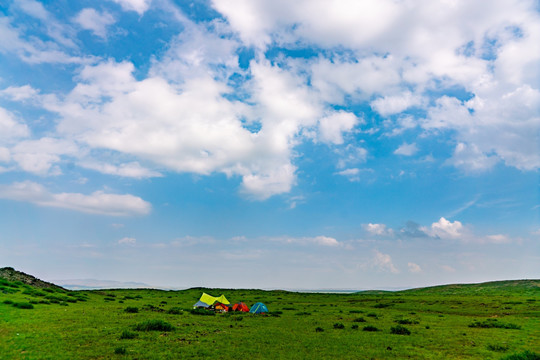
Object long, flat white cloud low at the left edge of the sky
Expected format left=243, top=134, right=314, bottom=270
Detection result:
left=0, top=181, right=151, bottom=216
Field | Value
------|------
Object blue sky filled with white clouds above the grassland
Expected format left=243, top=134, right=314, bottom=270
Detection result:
left=0, top=0, right=540, bottom=289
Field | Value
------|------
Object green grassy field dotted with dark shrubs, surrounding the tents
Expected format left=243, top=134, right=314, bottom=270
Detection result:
left=0, top=279, right=540, bottom=360
